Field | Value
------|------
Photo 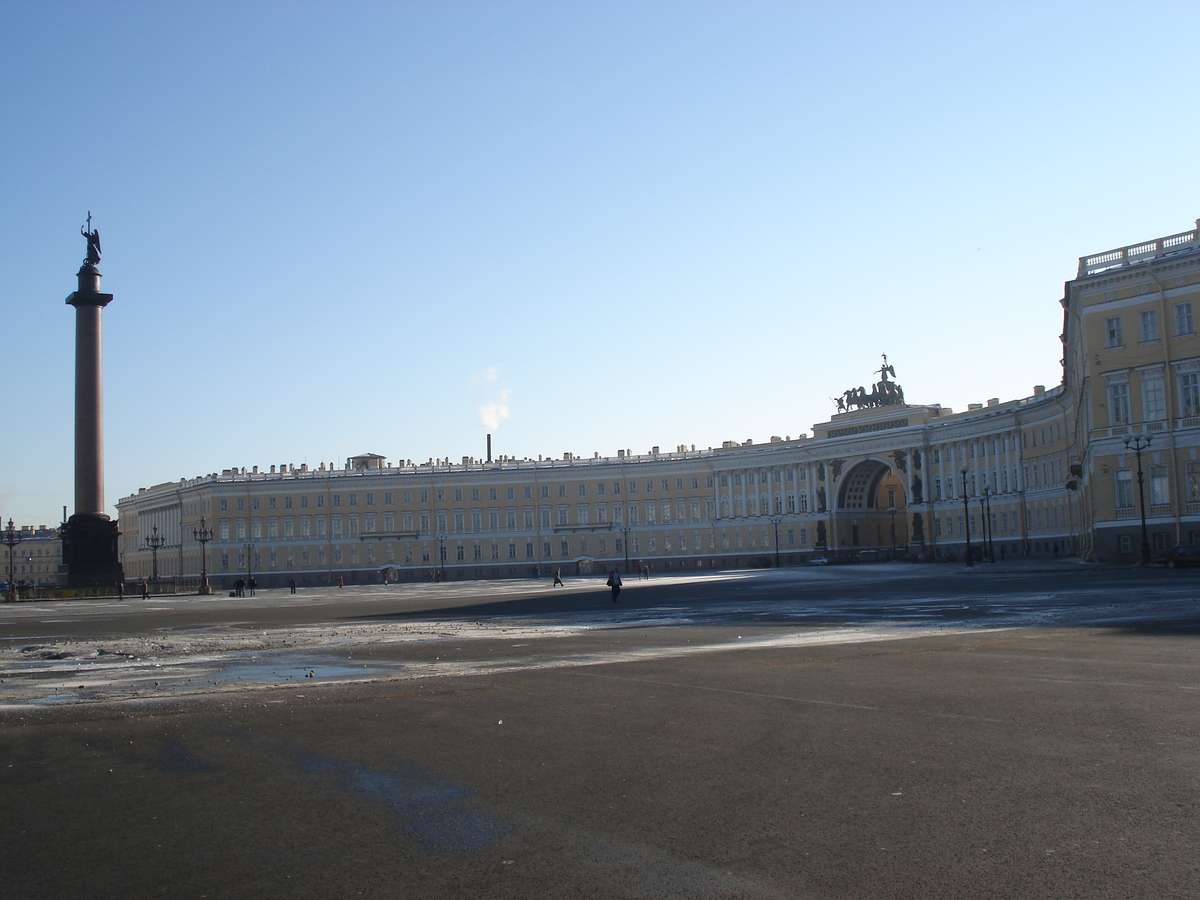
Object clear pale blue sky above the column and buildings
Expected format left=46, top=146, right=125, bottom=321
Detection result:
left=0, top=1, right=1200, bottom=524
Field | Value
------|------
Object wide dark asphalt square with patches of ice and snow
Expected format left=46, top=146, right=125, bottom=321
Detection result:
left=0, top=564, right=1200, bottom=899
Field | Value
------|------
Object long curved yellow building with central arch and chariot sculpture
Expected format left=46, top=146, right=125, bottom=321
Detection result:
left=118, top=217, right=1200, bottom=587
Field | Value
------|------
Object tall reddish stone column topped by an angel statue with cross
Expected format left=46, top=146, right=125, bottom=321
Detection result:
left=62, top=212, right=124, bottom=588
